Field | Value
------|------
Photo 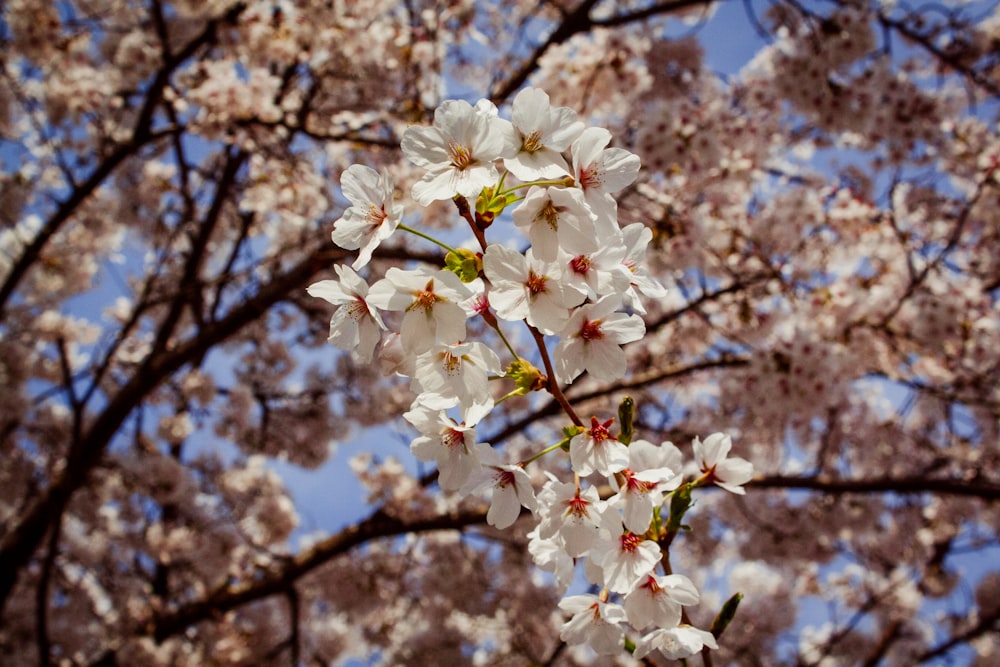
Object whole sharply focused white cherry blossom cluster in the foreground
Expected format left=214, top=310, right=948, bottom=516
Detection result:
left=308, top=88, right=753, bottom=658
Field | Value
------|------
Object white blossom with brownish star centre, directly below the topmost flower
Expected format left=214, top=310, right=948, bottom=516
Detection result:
left=513, top=186, right=599, bottom=262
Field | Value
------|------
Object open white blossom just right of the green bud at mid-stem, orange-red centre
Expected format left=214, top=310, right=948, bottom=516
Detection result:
left=483, top=243, right=584, bottom=334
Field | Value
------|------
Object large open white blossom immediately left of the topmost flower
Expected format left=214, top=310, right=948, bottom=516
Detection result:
left=401, top=100, right=504, bottom=206
